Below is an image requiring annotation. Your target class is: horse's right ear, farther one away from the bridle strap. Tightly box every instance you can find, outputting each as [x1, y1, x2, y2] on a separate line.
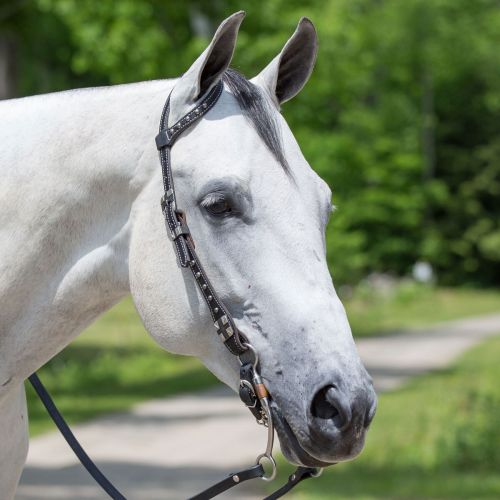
[252, 17, 318, 108]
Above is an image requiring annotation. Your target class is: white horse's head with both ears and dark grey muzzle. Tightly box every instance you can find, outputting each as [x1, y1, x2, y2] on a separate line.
[129, 13, 376, 466]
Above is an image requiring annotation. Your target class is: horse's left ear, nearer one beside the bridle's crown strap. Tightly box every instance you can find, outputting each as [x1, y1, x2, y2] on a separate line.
[168, 10, 245, 125]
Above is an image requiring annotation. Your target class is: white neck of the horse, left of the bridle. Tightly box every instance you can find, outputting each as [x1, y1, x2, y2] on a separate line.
[0, 81, 172, 383]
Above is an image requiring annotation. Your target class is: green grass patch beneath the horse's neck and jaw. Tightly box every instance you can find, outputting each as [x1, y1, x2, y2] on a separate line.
[26, 298, 218, 436]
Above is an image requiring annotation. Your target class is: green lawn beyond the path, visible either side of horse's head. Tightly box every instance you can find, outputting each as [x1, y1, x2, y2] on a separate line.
[27, 286, 500, 435]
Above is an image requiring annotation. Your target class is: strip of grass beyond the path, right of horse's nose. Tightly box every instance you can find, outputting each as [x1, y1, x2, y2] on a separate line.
[342, 283, 500, 337]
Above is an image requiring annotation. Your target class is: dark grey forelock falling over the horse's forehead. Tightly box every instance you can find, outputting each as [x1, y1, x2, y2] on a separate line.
[222, 69, 290, 174]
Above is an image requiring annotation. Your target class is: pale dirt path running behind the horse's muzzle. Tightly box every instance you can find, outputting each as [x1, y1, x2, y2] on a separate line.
[16, 314, 500, 500]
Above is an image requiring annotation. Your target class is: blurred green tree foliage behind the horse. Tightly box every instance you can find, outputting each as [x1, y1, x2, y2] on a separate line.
[0, 0, 500, 285]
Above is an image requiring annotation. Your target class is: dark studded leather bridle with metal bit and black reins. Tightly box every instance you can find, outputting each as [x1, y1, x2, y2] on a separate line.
[29, 81, 321, 500]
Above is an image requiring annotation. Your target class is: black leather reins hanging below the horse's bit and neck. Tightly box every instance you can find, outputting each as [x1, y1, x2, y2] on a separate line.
[28, 373, 317, 500]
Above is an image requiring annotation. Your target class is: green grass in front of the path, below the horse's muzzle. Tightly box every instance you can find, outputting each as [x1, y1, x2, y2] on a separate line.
[270, 337, 500, 500]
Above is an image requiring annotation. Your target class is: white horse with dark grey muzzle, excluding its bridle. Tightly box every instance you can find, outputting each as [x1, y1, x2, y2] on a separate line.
[0, 12, 376, 499]
